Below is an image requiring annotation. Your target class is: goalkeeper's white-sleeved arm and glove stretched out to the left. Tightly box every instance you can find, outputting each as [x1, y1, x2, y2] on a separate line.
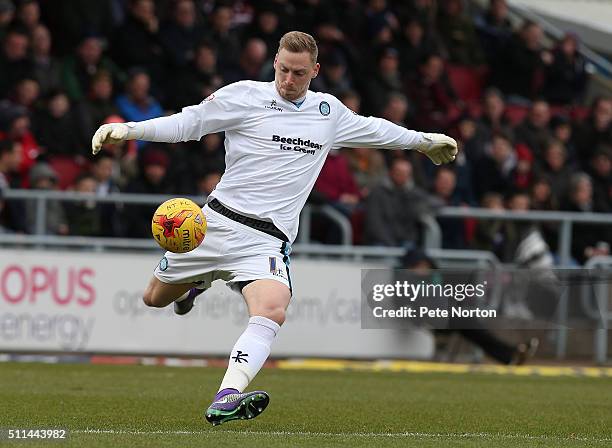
[91, 82, 250, 154]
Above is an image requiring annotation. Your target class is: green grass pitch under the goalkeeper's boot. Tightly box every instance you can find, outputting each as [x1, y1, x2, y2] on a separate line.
[0, 363, 612, 448]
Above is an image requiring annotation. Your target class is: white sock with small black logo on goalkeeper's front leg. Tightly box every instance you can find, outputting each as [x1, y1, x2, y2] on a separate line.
[219, 316, 280, 392]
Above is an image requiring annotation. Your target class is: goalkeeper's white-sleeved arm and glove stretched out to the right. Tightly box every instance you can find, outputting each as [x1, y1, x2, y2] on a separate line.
[334, 101, 457, 165]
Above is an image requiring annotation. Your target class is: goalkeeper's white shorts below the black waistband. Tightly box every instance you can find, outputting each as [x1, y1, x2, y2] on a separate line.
[155, 205, 291, 290]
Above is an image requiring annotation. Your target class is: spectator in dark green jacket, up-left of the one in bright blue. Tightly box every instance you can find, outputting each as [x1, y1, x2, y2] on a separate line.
[62, 36, 123, 101]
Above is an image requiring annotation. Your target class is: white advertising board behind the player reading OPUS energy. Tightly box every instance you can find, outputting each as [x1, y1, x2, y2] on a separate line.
[0, 249, 433, 358]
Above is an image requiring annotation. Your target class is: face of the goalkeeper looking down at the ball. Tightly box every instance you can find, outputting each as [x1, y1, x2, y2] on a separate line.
[274, 48, 319, 101]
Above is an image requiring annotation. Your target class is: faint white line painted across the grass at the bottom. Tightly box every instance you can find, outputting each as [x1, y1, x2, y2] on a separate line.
[70, 428, 612, 442]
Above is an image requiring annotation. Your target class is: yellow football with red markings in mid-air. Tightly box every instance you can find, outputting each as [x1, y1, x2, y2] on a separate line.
[151, 198, 206, 254]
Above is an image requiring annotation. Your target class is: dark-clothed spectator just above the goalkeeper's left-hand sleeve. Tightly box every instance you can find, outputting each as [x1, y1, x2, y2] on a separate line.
[168, 42, 225, 111]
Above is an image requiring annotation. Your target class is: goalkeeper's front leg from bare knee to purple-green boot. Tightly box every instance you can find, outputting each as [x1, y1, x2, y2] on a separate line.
[206, 279, 291, 425]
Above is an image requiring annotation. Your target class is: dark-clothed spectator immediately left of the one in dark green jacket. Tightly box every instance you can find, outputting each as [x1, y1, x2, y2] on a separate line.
[32, 25, 62, 96]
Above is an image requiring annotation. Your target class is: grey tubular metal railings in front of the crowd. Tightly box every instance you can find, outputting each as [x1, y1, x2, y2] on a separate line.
[0, 190, 612, 361]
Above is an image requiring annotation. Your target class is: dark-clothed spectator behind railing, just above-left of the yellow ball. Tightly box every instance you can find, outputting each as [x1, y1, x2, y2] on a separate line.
[125, 147, 174, 238]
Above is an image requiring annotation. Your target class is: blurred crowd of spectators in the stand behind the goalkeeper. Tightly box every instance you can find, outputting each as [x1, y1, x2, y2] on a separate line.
[0, 0, 612, 263]
